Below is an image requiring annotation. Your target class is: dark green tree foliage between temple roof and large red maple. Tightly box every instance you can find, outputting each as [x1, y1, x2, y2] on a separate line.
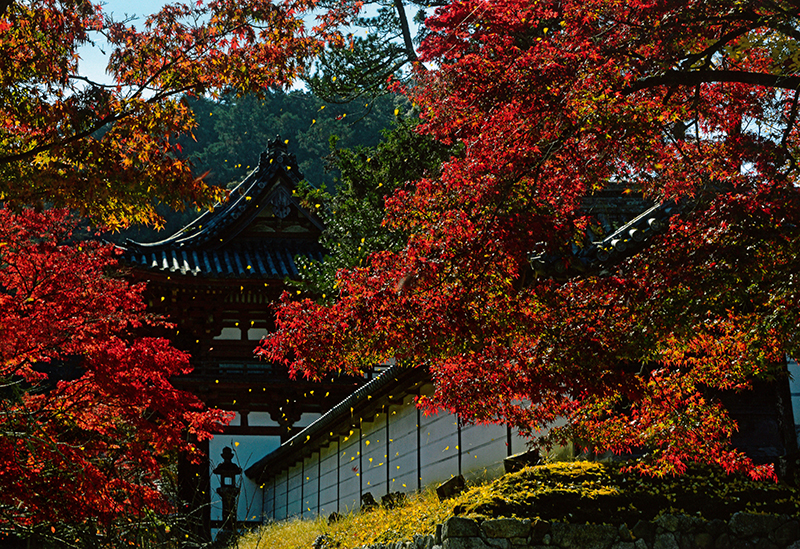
[297, 117, 457, 298]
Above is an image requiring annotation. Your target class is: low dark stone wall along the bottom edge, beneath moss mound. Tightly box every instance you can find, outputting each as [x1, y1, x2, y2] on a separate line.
[354, 513, 800, 549]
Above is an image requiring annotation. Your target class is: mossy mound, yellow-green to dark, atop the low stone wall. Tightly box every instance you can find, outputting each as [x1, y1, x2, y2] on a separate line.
[454, 462, 800, 524]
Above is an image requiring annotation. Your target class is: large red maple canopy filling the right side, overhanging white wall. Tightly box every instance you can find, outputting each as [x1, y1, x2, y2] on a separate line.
[259, 0, 800, 477]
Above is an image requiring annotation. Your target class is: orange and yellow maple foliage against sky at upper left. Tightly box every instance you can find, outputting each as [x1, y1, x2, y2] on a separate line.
[0, 0, 348, 228]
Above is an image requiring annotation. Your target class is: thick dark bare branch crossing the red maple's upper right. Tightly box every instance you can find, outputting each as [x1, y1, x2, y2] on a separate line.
[622, 70, 800, 95]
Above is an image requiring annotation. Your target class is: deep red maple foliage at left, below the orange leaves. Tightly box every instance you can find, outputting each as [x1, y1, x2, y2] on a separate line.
[0, 208, 229, 532]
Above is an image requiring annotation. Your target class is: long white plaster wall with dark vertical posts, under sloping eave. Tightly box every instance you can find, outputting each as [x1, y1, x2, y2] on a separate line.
[264, 397, 548, 520]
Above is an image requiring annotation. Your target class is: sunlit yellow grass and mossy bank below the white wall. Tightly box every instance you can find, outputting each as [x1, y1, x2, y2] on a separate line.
[228, 461, 800, 549]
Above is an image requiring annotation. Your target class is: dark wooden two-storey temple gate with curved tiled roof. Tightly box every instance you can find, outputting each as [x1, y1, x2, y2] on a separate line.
[120, 139, 365, 532]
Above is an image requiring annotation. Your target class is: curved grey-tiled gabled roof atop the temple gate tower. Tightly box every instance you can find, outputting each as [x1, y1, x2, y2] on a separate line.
[120, 138, 323, 280]
